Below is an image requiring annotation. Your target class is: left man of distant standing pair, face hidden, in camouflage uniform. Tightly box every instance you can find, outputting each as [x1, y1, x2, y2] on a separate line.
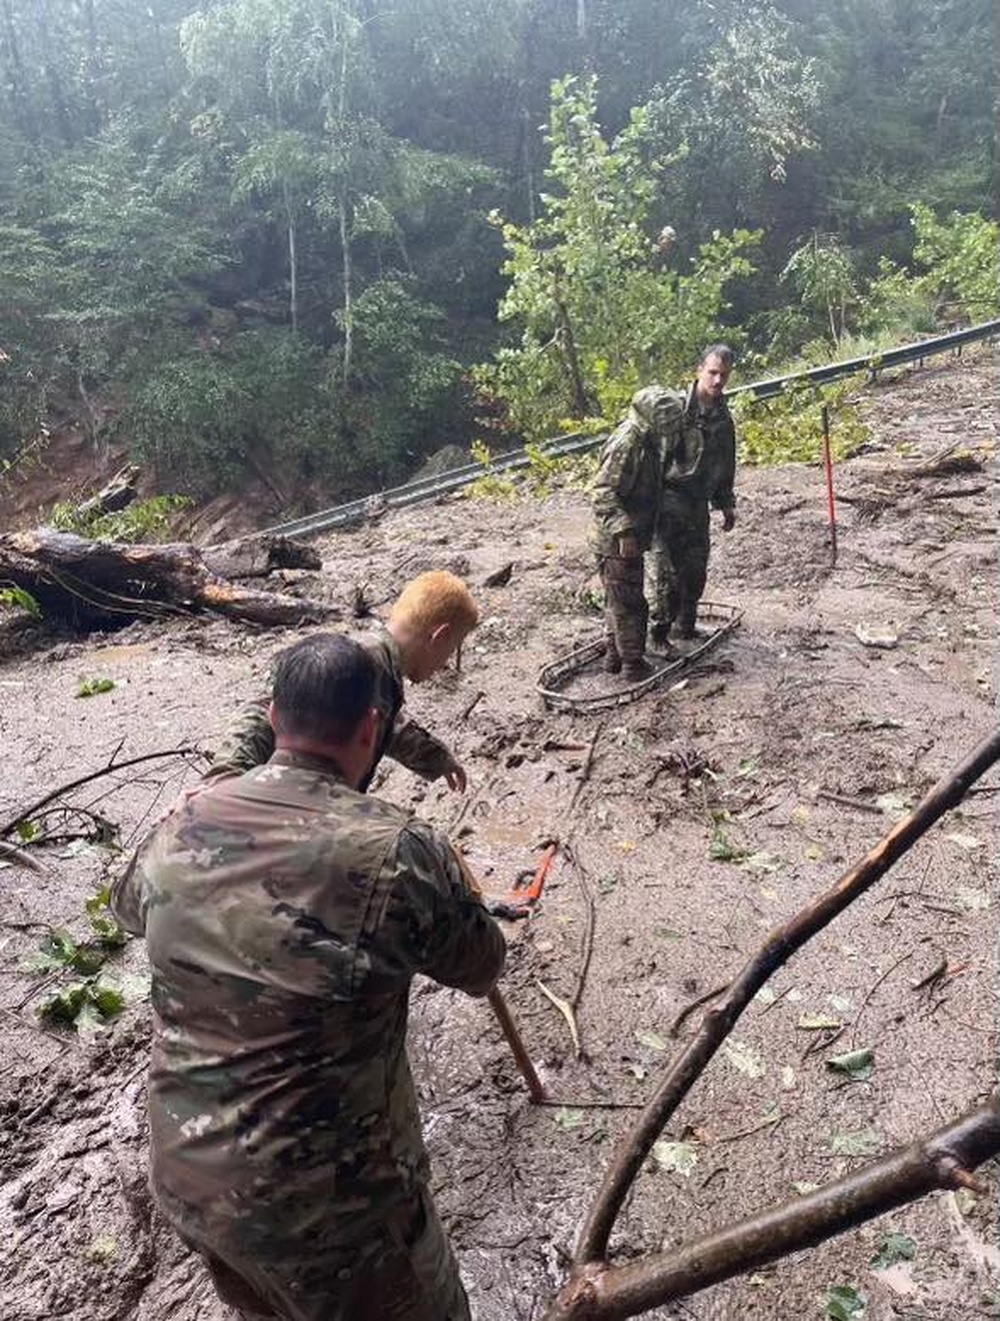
[593, 386, 680, 680]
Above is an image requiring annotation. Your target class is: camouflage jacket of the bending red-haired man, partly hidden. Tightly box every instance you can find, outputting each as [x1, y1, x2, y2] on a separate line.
[205, 629, 454, 791]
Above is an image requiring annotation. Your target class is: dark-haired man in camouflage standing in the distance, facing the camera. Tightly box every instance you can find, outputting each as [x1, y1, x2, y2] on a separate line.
[646, 343, 736, 646]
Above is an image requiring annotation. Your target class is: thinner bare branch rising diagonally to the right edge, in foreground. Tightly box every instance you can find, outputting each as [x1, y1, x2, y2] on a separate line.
[575, 729, 1000, 1262]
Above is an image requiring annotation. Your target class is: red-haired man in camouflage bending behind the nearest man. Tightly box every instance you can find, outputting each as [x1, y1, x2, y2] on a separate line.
[205, 569, 480, 791]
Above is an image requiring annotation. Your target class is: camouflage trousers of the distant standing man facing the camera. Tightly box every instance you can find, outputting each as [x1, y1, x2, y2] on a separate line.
[646, 490, 709, 635]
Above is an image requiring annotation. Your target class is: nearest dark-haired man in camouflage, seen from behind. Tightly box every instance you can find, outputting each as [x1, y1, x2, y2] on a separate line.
[111, 634, 505, 1321]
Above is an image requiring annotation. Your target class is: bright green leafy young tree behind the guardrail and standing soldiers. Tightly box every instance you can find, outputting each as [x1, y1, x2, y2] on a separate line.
[474, 78, 757, 439]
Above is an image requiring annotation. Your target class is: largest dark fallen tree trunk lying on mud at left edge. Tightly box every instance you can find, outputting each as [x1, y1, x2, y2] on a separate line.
[0, 527, 341, 627]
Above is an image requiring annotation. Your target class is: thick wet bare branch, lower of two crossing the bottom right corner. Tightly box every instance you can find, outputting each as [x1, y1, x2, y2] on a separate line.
[544, 1094, 1000, 1321]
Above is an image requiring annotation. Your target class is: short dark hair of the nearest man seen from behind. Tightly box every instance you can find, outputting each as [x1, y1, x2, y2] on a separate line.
[271, 633, 376, 744]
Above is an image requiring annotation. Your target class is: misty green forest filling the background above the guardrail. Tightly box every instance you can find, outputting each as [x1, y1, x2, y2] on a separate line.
[0, 0, 997, 503]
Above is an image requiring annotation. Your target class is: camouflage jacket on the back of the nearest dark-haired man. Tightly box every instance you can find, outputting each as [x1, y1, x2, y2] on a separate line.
[111, 750, 505, 1248]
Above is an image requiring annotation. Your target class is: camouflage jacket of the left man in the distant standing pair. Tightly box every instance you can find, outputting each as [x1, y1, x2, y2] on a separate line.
[593, 386, 683, 556]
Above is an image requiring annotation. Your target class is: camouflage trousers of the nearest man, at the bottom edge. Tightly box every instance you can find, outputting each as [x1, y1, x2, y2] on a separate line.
[169, 1190, 472, 1321]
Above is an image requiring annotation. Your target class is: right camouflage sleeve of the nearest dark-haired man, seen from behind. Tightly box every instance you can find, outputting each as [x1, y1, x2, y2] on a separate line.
[382, 820, 506, 996]
